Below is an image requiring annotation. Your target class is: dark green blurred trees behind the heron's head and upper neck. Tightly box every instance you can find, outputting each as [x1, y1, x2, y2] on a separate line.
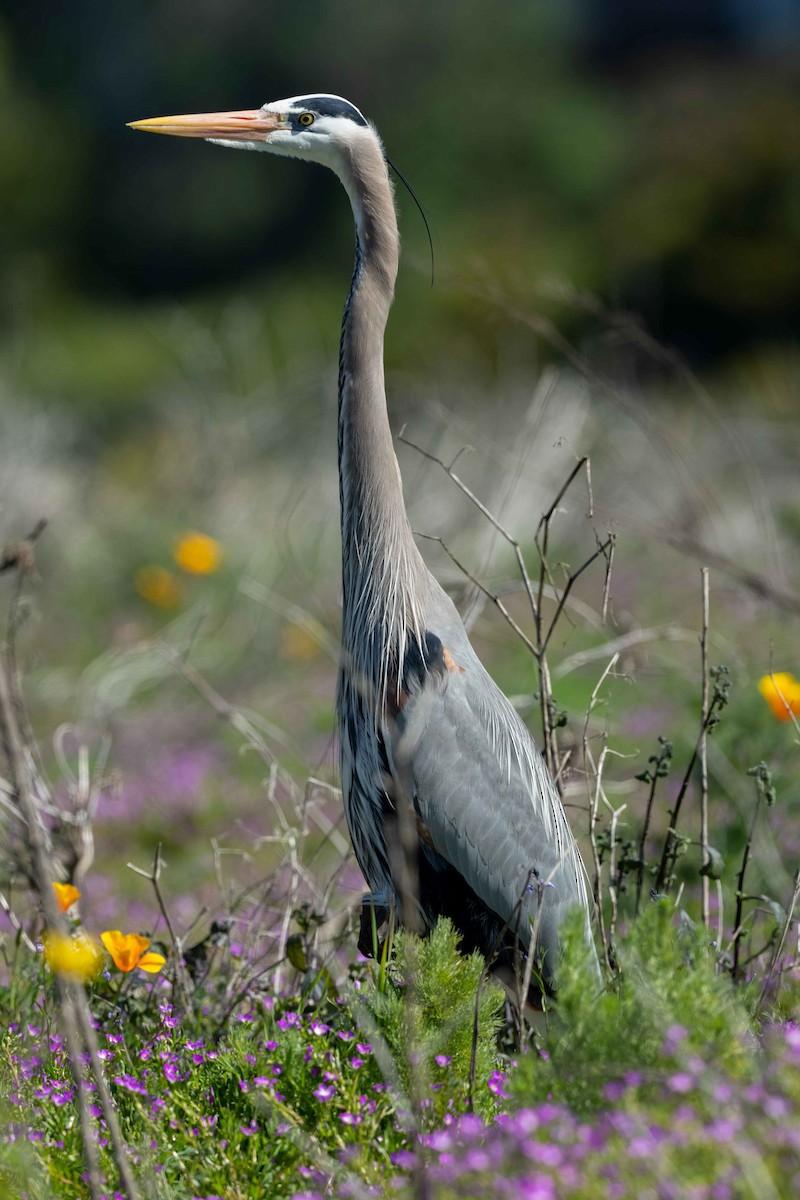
[0, 0, 800, 412]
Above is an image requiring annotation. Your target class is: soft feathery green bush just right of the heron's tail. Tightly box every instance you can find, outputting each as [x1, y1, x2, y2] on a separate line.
[513, 901, 753, 1111]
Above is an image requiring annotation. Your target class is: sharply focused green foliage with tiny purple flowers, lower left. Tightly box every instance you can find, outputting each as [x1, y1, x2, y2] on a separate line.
[0, 923, 499, 1200]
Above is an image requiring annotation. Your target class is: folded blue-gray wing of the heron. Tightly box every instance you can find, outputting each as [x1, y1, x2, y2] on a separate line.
[392, 580, 589, 962]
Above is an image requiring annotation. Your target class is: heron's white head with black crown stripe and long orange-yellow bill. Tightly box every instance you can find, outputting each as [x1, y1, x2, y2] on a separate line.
[131, 95, 372, 169]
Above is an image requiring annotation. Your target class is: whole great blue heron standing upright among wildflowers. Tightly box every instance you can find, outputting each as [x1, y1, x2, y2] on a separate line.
[133, 95, 596, 986]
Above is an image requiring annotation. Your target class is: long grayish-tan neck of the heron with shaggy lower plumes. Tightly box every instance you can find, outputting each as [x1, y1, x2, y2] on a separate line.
[338, 130, 427, 701]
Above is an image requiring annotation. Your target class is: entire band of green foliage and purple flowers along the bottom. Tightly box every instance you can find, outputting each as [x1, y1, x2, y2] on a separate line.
[0, 901, 800, 1200]
